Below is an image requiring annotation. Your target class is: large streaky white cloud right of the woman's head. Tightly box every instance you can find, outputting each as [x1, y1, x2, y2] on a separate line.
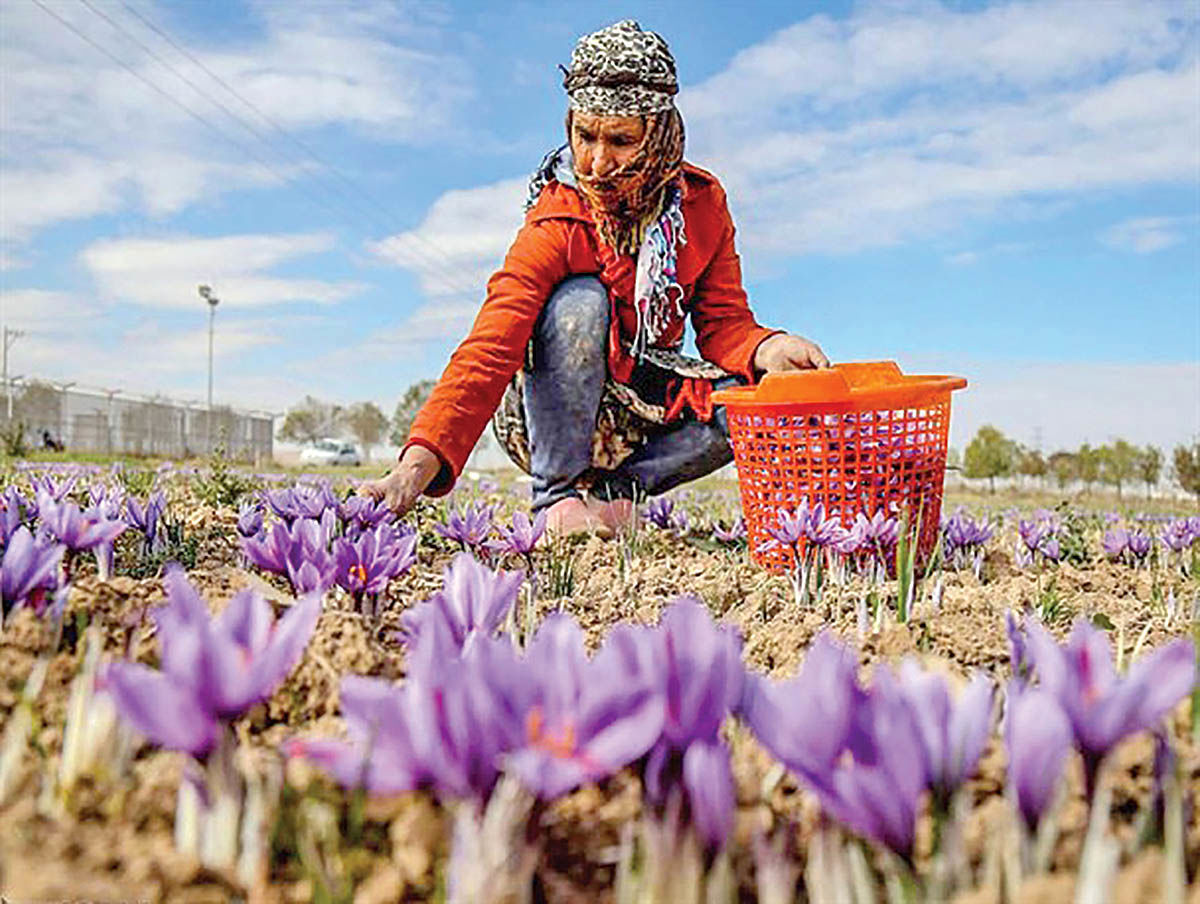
[679, 2, 1200, 255]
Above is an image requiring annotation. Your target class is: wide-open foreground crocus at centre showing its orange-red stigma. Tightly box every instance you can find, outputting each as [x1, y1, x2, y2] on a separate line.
[496, 615, 665, 801]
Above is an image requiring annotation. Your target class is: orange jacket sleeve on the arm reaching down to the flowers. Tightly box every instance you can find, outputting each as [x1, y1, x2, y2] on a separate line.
[401, 220, 568, 496]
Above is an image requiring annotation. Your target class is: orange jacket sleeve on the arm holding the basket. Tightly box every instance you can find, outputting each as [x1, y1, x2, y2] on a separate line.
[691, 186, 782, 383]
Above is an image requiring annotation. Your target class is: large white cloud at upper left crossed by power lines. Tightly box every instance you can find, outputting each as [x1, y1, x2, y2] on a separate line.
[0, 2, 472, 240]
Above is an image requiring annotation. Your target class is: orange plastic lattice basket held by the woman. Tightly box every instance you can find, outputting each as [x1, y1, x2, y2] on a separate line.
[713, 361, 967, 571]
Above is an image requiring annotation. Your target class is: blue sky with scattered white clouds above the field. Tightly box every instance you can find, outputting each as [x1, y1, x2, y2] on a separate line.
[0, 0, 1200, 448]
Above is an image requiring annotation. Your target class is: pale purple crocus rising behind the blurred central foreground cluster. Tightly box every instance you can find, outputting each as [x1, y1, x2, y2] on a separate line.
[401, 552, 524, 651]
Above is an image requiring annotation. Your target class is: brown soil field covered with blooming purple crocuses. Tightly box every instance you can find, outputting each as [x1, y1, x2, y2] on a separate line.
[0, 462, 1200, 904]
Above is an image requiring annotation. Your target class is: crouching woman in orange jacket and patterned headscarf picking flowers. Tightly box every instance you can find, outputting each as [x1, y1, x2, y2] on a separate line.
[364, 20, 828, 535]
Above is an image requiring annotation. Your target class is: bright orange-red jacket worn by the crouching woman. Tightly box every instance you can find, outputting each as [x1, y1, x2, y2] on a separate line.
[406, 163, 778, 496]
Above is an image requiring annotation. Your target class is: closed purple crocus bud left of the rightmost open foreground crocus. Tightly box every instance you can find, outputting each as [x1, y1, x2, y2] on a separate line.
[1004, 681, 1072, 832]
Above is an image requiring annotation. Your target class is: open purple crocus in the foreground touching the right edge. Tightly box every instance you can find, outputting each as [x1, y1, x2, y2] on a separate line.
[1025, 618, 1196, 797]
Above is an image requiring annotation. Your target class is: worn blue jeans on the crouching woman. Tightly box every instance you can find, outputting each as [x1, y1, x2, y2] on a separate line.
[523, 276, 742, 510]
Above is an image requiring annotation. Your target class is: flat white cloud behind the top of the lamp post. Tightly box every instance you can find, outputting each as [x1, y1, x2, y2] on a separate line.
[80, 234, 362, 309]
